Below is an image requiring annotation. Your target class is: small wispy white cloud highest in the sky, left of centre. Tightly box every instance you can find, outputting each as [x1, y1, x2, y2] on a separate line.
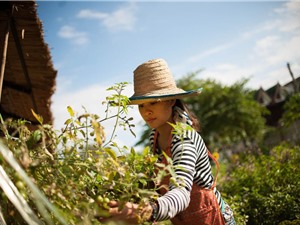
[77, 3, 137, 31]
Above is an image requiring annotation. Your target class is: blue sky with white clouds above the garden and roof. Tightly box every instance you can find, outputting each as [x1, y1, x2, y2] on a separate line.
[37, 1, 300, 149]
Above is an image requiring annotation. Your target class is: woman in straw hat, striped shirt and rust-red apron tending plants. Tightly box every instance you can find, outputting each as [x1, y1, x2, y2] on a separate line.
[99, 59, 235, 225]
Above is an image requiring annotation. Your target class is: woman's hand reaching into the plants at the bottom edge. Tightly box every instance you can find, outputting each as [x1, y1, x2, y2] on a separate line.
[99, 201, 152, 225]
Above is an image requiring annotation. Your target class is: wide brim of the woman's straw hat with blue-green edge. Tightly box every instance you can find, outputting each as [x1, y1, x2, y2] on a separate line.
[128, 88, 202, 105]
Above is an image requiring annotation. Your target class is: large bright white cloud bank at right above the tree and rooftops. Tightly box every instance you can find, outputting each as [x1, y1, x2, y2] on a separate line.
[178, 1, 300, 88]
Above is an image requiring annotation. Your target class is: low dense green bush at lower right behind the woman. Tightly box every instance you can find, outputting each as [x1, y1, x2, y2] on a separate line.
[222, 145, 300, 225]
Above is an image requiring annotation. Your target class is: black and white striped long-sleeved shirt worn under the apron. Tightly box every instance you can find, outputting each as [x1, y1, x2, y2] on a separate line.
[150, 129, 221, 221]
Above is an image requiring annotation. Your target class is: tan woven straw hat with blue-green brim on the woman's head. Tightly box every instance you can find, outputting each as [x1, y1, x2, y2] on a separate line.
[129, 59, 202, 105]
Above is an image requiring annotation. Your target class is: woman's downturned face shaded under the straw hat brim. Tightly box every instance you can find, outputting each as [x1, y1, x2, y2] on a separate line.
[138, 100, 175, 129]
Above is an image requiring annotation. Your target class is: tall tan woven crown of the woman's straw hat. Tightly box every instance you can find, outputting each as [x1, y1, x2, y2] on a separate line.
[133, 59, 183, 96]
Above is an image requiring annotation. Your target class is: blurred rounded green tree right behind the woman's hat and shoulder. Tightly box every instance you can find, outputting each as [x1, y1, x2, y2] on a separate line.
[178, 72, 267, 150]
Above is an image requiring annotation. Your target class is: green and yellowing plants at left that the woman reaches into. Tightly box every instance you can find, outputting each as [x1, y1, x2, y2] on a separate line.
[0, 83, 172, 225]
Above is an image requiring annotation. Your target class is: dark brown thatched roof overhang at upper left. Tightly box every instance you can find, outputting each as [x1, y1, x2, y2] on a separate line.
[0, 1, 57, 124]
